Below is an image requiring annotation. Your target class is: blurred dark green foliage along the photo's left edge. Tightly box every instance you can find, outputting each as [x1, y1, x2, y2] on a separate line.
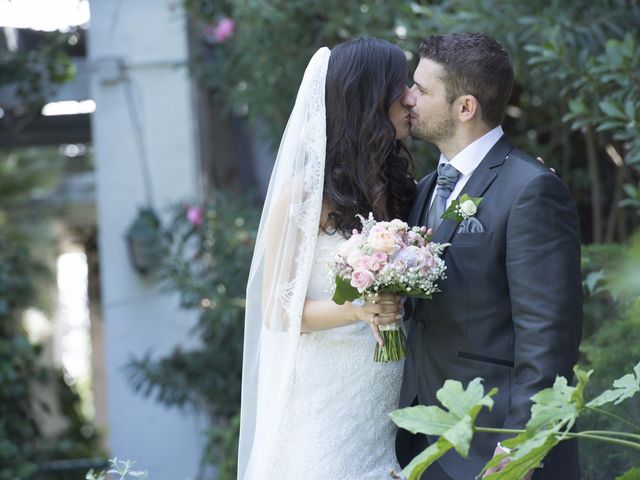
[0, 149, 98, 480]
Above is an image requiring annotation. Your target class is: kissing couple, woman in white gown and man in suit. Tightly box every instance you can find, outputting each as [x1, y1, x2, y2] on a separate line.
[238, 33, 582, 480]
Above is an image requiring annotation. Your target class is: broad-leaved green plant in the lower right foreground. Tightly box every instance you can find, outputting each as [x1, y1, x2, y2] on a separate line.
[390, 363, 640, 480]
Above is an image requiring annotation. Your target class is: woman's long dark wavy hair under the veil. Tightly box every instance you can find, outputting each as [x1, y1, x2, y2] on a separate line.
[323, 38, 416, 237]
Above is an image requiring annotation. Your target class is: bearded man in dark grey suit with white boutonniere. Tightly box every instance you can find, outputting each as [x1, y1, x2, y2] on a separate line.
[396, 33, 582, 480]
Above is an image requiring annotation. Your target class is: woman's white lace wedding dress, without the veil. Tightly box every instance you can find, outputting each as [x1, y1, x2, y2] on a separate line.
[269, 233, 403, 480]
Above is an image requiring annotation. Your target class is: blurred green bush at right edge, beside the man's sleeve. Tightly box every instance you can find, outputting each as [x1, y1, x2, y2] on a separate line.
[579, 240, 640, 480]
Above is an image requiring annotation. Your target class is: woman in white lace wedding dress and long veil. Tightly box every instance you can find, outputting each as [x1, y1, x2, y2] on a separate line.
[238, 39, 416, 480]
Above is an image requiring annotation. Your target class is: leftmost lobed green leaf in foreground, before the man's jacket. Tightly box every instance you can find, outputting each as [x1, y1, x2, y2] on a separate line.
[389, 378, 498, 479]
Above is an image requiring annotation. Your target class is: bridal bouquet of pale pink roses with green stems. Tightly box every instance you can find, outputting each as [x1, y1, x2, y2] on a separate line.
[331, 214, 448, 362]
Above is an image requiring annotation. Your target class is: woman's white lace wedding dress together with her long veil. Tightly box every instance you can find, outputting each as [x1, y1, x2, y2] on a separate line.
[238, 47, 403, 480]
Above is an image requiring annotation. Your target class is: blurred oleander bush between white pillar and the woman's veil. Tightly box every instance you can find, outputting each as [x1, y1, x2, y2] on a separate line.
[128, 194, 259, 479]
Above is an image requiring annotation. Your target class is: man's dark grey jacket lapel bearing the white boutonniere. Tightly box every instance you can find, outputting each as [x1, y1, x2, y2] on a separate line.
[432, 135, 513, 243]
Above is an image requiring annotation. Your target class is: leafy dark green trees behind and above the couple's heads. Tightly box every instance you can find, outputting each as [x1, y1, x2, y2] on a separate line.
[186, 0, 640, 242]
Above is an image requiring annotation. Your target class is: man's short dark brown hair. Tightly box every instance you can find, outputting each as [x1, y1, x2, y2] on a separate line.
[420, 33, 513, 127]
